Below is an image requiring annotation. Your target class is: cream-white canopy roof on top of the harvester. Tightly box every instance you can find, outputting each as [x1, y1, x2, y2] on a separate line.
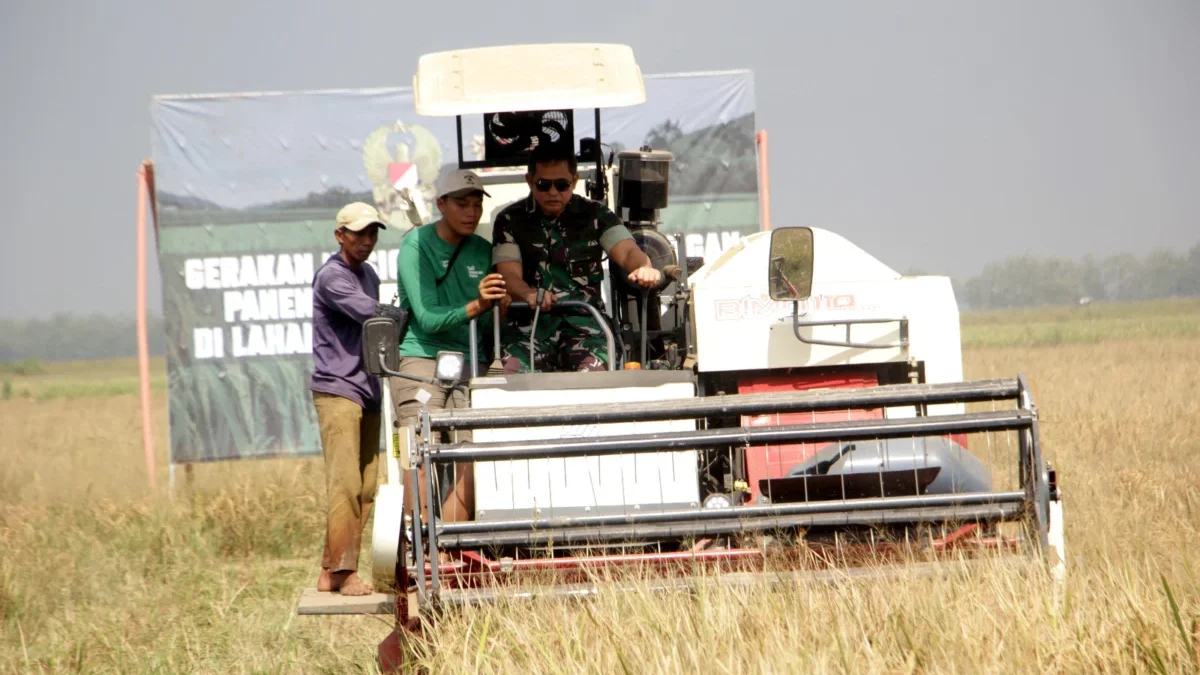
[413, 43, 646, 117]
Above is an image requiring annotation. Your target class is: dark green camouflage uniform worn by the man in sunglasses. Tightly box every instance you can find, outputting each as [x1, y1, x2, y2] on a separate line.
[492, 195, 632, 372]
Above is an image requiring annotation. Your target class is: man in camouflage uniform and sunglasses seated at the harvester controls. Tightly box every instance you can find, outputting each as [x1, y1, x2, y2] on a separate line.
[492, 143, 662, 374]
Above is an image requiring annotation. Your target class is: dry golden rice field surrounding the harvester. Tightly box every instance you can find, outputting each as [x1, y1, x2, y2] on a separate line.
[0, 305, 1200, 673]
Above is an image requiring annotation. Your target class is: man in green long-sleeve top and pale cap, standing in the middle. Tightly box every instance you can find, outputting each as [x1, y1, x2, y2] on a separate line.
[389, 169, 511, 520]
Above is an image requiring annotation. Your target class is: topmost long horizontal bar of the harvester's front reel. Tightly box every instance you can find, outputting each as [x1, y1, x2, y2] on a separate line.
[430, 378, 1020, 430]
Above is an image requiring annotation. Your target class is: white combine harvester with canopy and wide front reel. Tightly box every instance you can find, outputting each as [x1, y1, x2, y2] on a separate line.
[300, 44, 1064, 668]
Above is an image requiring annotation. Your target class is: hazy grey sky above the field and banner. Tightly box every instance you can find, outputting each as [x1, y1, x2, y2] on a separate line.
[0, 0, 1200, 317]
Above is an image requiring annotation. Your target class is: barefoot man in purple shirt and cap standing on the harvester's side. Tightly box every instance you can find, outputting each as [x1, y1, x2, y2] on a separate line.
[308, 202, 384, 596]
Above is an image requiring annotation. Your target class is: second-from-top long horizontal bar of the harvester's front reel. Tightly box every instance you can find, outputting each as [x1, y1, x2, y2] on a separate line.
[428, 410, 1036, 464]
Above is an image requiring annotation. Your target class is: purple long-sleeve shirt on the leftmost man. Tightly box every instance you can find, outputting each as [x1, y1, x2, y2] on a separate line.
[308, 253, 383, 410]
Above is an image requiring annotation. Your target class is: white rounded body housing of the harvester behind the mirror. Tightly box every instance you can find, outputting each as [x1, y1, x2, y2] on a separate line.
[689, 227, 962, 416]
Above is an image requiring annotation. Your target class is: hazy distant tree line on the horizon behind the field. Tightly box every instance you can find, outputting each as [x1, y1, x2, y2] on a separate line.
[0, 243, 1200, 364]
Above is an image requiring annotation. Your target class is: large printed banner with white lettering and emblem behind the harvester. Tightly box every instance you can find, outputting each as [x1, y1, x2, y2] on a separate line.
[151, 71, 758, 464]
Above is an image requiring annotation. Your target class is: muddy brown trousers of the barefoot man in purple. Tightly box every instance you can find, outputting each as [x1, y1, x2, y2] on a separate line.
[312, 392, 380, 572]
